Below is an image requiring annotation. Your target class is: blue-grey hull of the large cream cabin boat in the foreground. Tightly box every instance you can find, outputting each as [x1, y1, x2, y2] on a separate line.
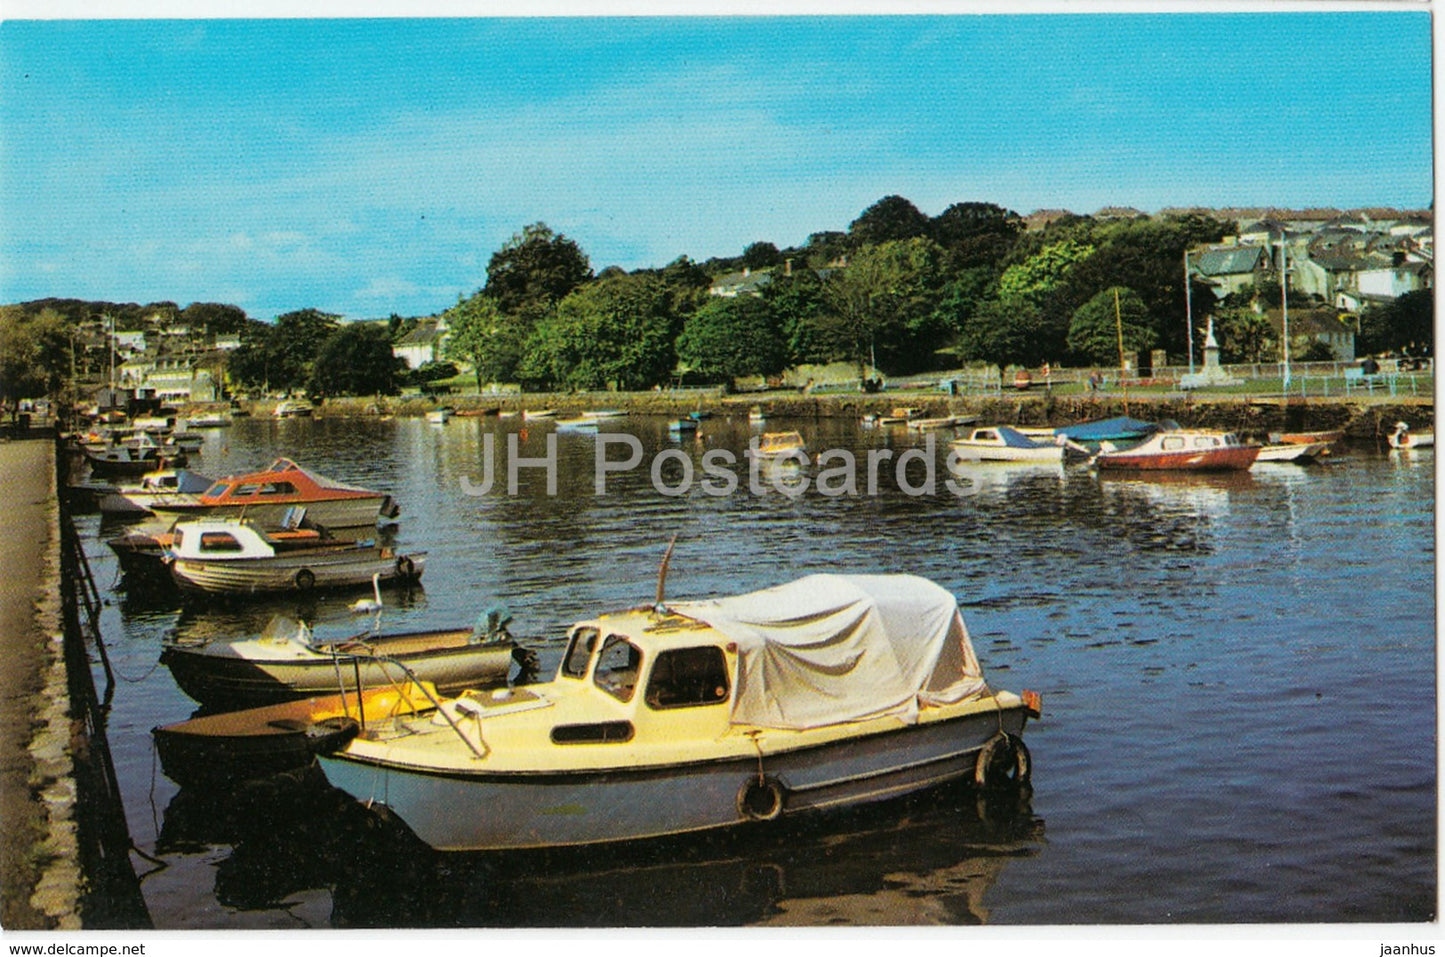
[318, 707, 1027, 850]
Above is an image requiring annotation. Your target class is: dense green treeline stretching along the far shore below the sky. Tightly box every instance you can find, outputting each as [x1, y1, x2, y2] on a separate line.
[0, 195, 1432, 395]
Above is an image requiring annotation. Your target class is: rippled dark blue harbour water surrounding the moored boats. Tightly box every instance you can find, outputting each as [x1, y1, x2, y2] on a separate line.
[79, 416, 1438, 930]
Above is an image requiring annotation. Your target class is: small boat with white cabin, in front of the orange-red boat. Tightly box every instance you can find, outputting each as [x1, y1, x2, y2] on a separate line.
[165, 519, 426, 596]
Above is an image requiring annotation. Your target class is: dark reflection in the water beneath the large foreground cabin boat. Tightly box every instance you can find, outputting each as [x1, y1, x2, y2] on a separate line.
[156, 766, 1043, 928]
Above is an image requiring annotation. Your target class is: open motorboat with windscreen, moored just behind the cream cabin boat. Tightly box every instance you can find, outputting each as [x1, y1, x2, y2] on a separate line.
[160, 617, 517, 705]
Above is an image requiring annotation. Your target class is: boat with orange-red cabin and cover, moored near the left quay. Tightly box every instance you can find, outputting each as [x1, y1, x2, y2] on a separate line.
[152, 458, 402, 528]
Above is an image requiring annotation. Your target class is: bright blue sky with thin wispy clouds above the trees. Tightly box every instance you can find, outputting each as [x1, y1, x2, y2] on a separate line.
[0, 7, 1432, 318]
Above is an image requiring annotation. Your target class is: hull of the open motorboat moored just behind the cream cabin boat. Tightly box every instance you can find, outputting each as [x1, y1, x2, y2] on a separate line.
[160, 629, 516, 705]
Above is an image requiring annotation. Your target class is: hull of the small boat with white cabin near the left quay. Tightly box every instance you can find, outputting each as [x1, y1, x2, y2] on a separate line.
[171, 548, 426, 596]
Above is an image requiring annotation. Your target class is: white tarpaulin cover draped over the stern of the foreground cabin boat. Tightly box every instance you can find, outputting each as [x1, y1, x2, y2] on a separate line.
[669, 575, 984, 729]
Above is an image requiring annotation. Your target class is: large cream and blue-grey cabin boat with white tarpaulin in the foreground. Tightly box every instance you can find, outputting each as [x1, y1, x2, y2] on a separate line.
[318, 575, 1039, 850]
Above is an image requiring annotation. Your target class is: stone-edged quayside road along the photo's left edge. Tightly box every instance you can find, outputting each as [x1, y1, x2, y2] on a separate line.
[0, 438, 78, 930]
